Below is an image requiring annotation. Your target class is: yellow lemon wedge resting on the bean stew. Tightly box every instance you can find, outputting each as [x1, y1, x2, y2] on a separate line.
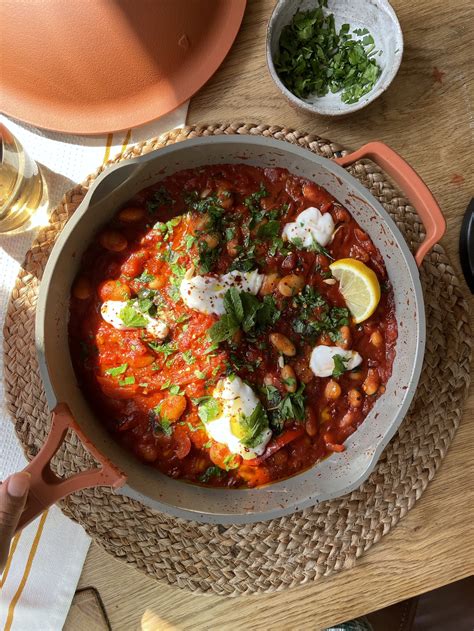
[329, 259, 380, 324]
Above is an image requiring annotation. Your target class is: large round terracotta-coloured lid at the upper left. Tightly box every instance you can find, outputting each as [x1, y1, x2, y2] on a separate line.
[0, 0, 246, 134]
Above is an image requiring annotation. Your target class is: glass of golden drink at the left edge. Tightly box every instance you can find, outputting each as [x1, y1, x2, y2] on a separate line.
[0, 123, 48, 234]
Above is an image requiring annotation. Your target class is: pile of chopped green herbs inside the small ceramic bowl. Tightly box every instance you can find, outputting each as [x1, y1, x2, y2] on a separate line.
[275, 0, 382, 104]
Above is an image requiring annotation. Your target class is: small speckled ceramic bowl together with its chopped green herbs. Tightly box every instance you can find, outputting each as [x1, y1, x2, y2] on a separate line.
[266, 0, 403, 116]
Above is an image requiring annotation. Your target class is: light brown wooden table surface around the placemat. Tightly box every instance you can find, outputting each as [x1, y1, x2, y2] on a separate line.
[65, 0, 474, 631]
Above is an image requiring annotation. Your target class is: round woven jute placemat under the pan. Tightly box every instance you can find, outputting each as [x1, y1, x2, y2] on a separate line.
[4, 123, 472, 595]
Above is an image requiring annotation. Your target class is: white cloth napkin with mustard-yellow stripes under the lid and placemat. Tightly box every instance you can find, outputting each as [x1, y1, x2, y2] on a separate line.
[0, 103, 188, 631]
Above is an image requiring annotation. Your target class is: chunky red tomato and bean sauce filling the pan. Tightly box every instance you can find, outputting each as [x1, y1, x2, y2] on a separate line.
[69, 165, 397, 488]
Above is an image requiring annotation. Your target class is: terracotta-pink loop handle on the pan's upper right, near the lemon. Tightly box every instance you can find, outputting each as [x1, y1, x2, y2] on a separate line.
[335, 142, 446, 267]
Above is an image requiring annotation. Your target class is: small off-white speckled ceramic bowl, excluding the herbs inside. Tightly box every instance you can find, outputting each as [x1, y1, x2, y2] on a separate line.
[267, 0, 403, 116]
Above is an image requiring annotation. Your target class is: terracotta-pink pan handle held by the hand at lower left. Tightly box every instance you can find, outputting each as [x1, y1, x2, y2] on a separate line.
[17, 403, 127, 530]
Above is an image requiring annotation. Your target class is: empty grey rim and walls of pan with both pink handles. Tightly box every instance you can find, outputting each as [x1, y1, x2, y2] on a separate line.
[14, 135, 445, 525]
